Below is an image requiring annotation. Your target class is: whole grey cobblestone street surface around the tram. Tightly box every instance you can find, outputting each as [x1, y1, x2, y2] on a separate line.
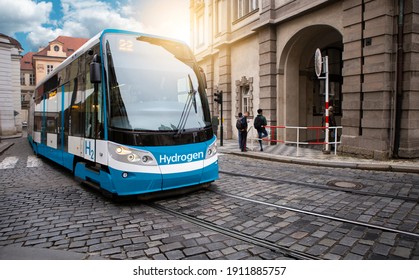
[0, 138, 419, 259]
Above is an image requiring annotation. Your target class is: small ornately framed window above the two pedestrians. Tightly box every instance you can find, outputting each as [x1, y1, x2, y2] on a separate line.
[236, 76, 253, 117]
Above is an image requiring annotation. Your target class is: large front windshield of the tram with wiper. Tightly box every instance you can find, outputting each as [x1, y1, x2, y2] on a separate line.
[104, 34, 211, 132]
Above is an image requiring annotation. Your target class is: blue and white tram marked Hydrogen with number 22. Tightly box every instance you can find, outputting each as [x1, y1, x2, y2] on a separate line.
[28, 29, 218, 196]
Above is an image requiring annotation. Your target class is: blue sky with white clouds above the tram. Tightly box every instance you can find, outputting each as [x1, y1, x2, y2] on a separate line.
[0, 0, 190, 54]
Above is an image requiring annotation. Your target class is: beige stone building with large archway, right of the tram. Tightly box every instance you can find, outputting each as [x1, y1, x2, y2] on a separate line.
[190, 0, 419, 159]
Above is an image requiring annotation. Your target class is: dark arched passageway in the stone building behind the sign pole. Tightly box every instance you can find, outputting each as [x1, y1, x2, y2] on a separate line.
[277, 25, 343, 141]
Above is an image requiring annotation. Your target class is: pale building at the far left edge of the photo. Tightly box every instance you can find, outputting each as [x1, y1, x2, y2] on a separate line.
[0, 34, 23, 137]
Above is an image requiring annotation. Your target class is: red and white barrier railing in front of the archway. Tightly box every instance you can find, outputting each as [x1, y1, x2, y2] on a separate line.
[247, 125, 343, 156]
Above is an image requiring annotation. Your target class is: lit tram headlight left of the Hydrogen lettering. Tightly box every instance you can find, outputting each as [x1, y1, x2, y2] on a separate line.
[108, 142, 157, 165]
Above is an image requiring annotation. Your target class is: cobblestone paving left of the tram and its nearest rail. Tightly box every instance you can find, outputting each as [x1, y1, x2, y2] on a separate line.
[0, 139, 292, 259]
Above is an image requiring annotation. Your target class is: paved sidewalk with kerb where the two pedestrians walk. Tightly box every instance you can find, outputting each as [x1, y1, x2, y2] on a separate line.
[218, 140, 419, 174]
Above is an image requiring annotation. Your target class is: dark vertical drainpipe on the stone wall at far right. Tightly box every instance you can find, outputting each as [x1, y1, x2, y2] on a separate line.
[393, 0, 404, 158]
